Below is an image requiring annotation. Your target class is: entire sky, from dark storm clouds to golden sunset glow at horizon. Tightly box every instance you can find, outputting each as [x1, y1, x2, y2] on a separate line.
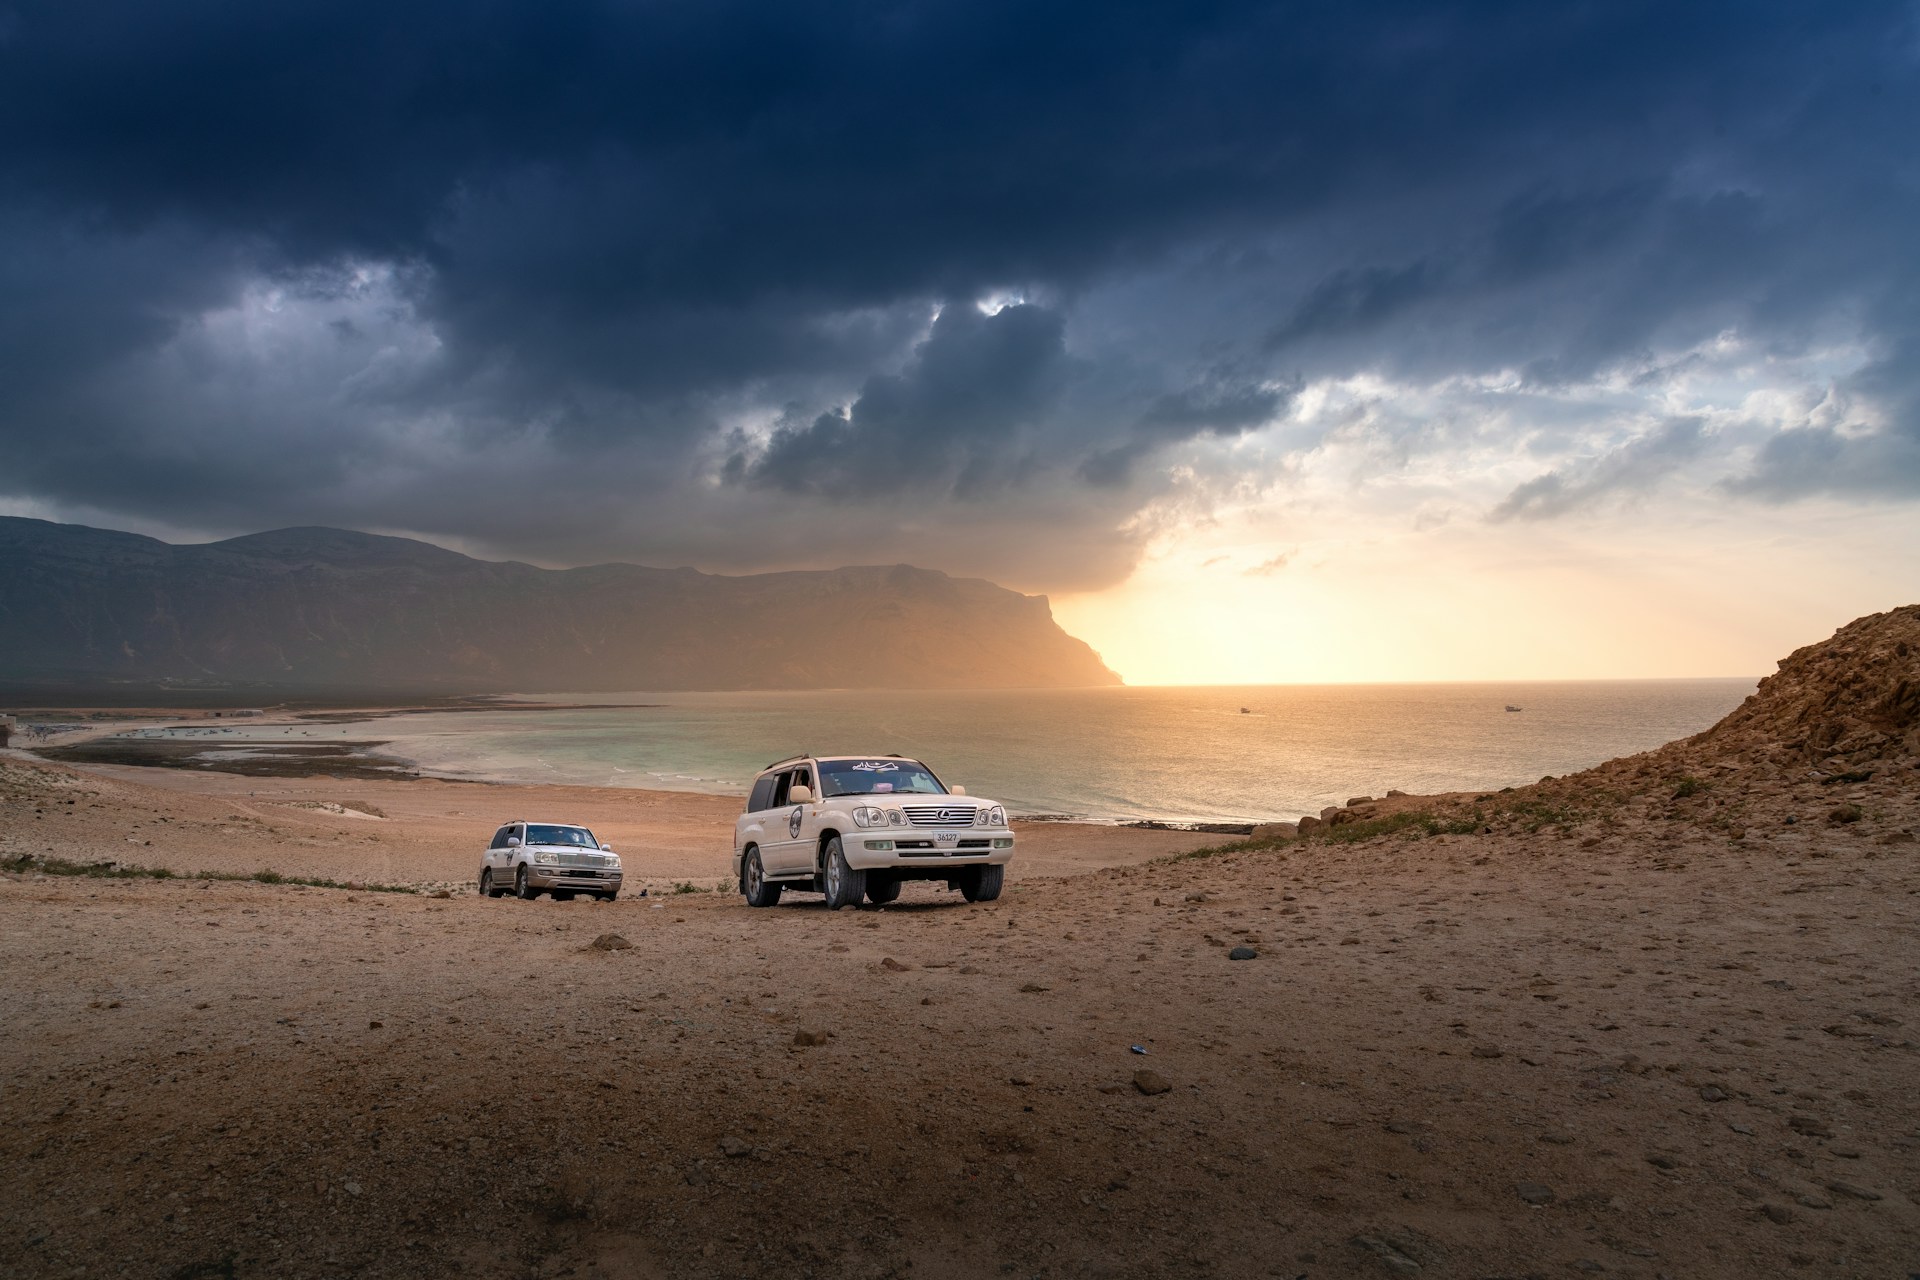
[0, 0, 1920, 683]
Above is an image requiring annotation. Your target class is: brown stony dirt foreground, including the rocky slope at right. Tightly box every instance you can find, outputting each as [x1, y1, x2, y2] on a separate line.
[0, 608, 1920, 1280]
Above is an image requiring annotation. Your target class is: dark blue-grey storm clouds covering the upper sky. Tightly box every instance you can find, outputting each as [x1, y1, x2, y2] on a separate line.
[0, 0, 1920, 585]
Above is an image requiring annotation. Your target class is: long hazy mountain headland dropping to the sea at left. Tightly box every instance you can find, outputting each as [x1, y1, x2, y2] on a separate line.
[0, 518, 1119, 693]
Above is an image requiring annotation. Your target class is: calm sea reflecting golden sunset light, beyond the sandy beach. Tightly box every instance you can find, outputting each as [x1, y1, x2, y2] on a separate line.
[251, 677, 1757, 823]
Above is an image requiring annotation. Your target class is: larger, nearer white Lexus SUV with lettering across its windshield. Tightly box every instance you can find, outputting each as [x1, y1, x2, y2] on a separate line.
[733, 756, 1014, 908]
